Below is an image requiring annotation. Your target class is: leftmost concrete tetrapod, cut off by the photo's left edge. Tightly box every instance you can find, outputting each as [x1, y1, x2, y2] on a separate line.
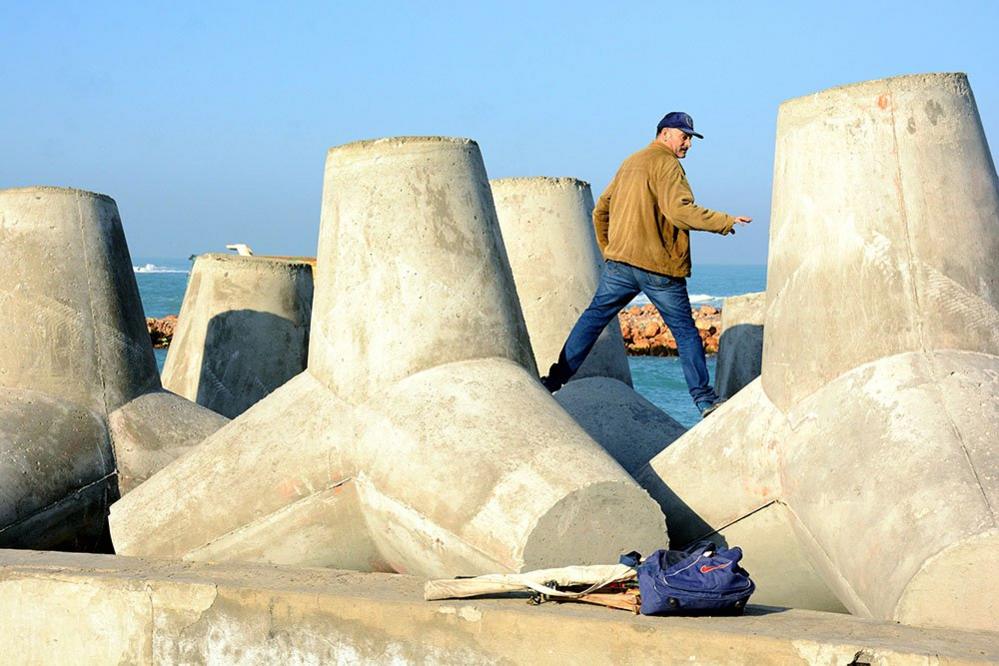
[0, 187, 226, 548]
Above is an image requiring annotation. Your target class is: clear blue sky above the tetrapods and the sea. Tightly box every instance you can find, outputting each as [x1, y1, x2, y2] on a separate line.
[0, 1, 999, 264]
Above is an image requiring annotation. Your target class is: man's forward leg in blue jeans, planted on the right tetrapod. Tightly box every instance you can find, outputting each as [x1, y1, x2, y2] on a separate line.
[636, 269, 718, 404]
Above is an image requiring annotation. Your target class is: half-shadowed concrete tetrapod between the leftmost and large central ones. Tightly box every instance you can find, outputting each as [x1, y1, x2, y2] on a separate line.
[163, 254, 315, 418]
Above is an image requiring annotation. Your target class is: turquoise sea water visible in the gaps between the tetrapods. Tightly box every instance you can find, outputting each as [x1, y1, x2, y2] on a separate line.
[133, 257, 767, 427]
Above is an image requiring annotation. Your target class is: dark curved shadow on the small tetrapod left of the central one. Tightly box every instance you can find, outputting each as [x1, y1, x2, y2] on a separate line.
[197, 310, 309, 418]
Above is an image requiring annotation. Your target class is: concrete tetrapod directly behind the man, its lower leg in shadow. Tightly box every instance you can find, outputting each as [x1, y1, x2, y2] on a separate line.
[490, 177, 686, 474]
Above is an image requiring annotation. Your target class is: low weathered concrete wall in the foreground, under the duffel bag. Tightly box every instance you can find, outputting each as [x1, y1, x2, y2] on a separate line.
[0, 551, 999, 666]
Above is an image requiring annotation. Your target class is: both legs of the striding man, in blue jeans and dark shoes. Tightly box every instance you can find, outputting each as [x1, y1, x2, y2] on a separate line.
[544, 261, 718, 404]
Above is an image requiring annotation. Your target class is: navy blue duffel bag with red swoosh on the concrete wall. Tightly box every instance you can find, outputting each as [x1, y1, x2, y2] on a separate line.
[621, 541, 756, 615]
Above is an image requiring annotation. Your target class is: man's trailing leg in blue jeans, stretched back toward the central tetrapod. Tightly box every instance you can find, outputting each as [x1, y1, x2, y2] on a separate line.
[541, 261, 640, 393]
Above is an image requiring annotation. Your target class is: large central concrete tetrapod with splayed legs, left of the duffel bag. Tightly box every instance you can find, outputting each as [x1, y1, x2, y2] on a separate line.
[111, 137, 665, 576]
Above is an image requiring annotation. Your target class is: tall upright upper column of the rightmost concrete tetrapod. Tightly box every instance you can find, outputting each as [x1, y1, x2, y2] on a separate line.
[763, 74, 999, 410]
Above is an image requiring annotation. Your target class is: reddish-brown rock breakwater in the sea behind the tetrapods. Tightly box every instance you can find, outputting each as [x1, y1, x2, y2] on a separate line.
[146, 304, 722, 356]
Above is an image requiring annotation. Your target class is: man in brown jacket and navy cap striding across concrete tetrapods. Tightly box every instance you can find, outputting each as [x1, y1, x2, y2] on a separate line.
[541, 111, 752, 416]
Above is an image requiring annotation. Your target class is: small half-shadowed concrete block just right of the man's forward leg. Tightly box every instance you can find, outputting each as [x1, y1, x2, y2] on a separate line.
[715, 291, 767, 400]
